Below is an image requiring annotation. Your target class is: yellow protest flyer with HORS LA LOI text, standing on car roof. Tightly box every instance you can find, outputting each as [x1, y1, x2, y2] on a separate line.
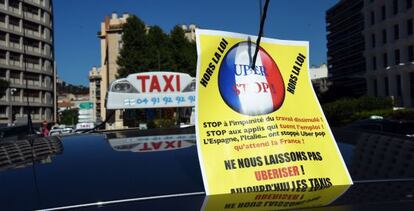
[196, 30, 352, 195]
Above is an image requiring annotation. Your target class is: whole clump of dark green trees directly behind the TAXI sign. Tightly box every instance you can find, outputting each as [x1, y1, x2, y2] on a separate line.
[117, 16, 197, 78]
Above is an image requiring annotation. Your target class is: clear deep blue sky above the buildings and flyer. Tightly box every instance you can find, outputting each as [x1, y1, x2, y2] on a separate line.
[53, 0, 338, 86]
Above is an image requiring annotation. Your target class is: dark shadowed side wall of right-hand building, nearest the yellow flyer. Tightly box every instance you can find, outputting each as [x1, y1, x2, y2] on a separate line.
[326, 0, 366, 97]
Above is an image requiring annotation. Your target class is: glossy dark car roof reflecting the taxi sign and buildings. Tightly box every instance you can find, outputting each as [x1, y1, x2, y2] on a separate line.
[0, 127, 414, 210]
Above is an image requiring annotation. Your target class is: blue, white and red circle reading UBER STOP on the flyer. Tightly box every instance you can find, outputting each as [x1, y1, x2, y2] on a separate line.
[218, 42, 285, 116]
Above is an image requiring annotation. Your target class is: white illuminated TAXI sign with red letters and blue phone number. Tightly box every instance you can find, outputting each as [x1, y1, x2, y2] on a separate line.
[106, 72, 195, 109]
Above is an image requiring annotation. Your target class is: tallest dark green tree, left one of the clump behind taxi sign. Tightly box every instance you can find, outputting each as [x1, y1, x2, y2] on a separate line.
[117, 15, 149, 78]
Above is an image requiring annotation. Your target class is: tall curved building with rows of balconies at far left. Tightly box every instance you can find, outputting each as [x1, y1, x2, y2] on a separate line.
[0, 0, 56, 124]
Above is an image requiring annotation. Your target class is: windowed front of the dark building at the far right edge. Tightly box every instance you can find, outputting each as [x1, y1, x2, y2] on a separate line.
[363, 0, 414, 107]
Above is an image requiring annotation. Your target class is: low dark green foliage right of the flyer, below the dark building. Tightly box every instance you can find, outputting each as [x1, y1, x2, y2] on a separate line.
[322, 97, 392, 126]
